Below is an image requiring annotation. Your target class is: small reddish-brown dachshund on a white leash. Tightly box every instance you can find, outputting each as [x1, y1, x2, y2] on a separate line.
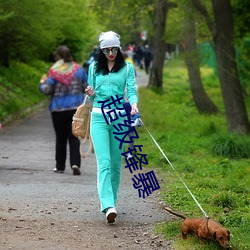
[163, 207, 231, 249]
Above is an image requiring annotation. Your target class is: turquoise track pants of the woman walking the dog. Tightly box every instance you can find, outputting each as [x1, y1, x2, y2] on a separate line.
[90, 112, 125, 212]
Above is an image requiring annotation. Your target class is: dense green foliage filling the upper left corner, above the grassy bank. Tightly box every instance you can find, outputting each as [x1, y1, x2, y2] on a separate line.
[0, 0, 99, 67]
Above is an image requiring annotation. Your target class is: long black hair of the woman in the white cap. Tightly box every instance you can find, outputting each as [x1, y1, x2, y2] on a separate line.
[96, 49, 126, 75]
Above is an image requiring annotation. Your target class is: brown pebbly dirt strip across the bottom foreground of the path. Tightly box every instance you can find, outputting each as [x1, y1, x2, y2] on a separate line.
[0, 214, 173, 250]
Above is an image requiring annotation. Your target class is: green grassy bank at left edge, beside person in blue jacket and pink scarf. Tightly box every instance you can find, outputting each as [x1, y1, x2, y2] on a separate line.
[0, 61, 48, 123]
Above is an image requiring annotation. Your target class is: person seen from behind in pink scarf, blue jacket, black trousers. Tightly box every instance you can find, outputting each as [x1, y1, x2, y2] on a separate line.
[39, 46, 87, 175]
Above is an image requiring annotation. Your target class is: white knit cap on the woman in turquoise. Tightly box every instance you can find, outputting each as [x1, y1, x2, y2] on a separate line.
[99, 31, 121, 49]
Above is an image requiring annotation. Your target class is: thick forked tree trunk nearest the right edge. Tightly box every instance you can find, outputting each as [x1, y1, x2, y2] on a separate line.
[191, 0, 250, 134]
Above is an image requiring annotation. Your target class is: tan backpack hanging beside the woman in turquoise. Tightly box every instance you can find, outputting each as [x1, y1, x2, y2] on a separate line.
[72, 95, 94, 158]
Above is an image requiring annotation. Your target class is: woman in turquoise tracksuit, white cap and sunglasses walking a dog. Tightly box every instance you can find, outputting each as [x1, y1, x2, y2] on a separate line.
[86, 31, 138, 223]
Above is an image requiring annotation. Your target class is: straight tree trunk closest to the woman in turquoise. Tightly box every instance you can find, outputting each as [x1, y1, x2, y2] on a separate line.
[148, 0, 168, 89]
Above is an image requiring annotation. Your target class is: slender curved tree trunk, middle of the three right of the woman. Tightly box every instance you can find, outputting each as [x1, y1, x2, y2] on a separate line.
[185, 3, 218, 114]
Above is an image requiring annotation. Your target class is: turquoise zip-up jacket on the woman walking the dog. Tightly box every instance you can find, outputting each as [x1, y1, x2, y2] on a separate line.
[88, 62, 138, 108]
